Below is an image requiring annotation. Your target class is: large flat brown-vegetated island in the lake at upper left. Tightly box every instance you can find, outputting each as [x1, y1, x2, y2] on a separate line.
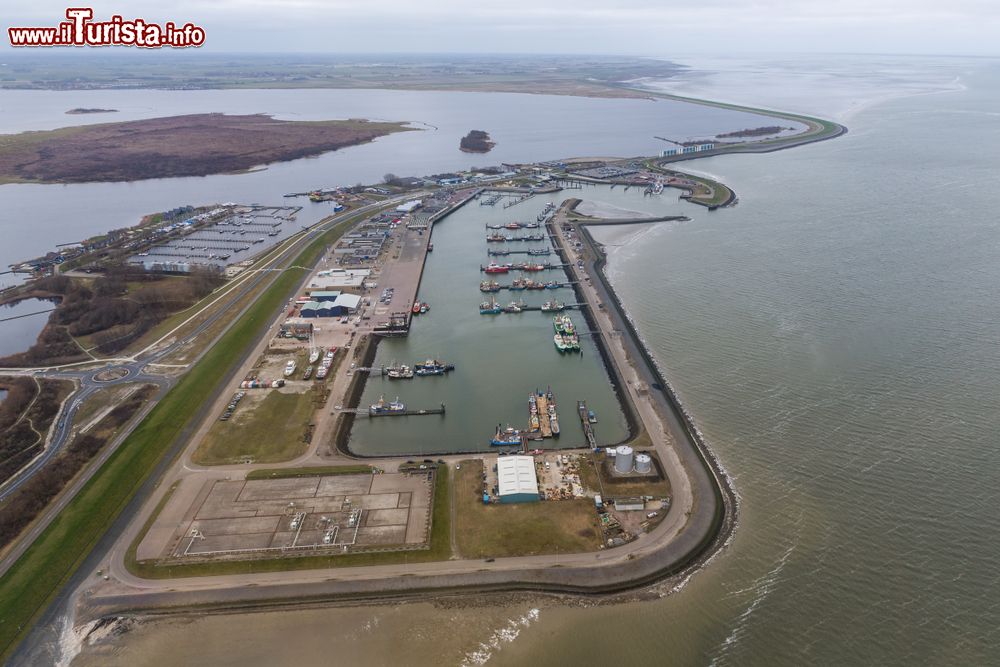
[0, 113, 413, 183]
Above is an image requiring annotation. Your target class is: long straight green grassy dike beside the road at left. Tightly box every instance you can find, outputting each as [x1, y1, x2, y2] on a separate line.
[0, 211, 368, 659]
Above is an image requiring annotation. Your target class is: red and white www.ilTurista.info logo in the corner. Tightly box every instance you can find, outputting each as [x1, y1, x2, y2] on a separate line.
[7, 7, 205, 49]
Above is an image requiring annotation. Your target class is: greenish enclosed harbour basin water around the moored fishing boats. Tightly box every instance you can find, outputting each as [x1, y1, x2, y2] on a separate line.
[348, 188, 640, 456]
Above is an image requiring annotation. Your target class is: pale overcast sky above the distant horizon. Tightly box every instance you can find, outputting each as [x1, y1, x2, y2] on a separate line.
[2, 0, 1000, 57]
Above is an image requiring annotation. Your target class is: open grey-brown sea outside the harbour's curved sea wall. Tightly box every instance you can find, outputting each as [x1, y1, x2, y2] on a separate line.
[68, 59, 1000, 666]
